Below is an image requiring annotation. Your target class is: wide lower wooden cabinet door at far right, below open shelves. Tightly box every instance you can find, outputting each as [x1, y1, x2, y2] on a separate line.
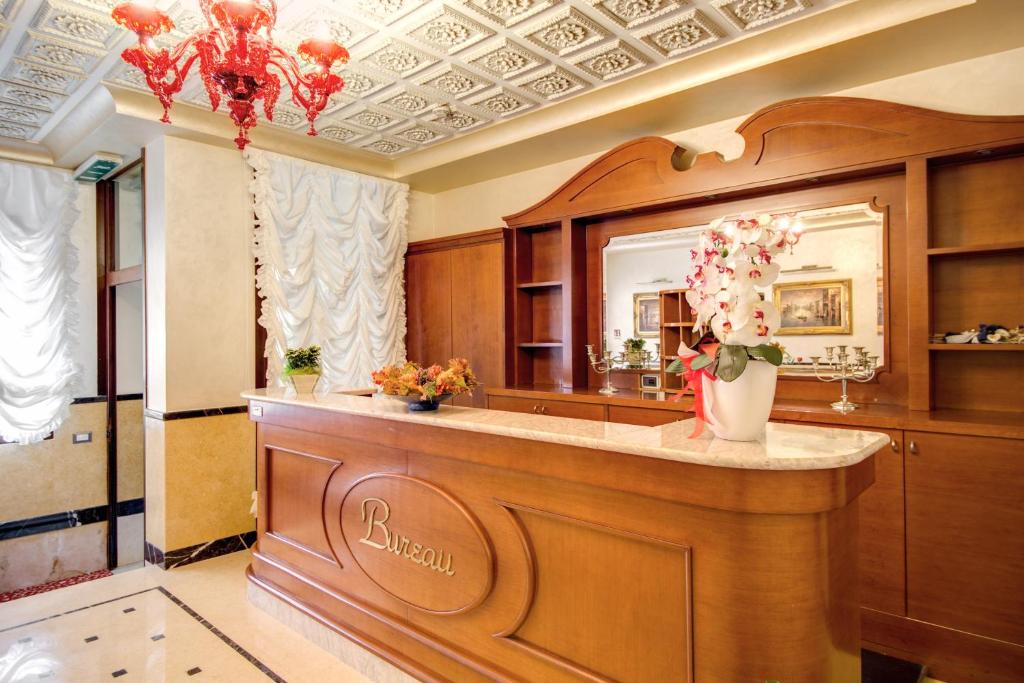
[906, 432, 1024, 644]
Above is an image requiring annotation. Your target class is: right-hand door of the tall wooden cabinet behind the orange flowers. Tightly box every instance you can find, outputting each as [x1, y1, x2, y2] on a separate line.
[454, 242, 505, 408]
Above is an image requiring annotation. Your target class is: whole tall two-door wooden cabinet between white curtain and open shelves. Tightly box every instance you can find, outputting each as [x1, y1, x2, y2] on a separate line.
[406, 229, 508, 408]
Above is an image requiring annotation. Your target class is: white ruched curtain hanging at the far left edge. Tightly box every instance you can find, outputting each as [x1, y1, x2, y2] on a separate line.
[0, 161, 79, 443]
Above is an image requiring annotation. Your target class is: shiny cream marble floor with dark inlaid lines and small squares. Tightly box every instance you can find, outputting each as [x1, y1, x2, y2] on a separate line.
[0, 551, 950, 683]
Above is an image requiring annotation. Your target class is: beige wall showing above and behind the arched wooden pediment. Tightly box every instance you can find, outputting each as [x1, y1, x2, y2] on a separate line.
[409, 48, 1024, 242]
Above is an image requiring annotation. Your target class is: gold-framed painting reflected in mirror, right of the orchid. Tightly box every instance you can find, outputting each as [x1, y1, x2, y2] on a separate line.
[772, 280, 853, 335]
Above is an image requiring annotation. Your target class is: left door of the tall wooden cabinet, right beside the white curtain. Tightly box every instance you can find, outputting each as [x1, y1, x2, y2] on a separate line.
[406, 251, 452, 365]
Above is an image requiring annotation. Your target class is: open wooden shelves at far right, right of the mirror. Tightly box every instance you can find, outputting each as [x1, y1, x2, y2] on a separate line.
[925, 154, 1024, 412]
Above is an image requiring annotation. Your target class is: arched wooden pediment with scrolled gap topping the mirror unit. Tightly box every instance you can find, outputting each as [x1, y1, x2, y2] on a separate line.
[505, 97, 1024, 227]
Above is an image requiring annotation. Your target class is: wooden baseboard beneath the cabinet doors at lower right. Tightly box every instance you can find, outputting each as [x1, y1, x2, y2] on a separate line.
[860, 607, 1024, 683]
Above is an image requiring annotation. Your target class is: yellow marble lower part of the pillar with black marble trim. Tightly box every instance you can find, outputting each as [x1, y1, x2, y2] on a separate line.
[145, 407, 256, 569]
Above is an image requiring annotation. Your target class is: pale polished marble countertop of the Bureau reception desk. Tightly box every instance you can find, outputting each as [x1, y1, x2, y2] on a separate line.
[242, 389, 889, 470]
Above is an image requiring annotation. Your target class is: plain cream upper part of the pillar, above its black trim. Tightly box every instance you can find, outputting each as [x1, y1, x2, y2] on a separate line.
[145, 137, 255, 412]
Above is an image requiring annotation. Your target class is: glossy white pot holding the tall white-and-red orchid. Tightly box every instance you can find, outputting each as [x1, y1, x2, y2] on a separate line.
[703, 360, 778, 441]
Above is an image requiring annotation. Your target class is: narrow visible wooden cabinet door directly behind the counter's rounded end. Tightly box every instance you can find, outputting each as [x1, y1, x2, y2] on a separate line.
[860, 428, 906, 616]
